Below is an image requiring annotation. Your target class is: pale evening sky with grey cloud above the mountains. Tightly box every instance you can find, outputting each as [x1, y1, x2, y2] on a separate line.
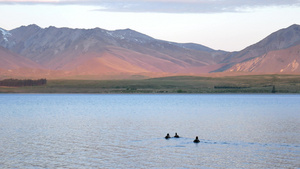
[0, 0, 300, 51]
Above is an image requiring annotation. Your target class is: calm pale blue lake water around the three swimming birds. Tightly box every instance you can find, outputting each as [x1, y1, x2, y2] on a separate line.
[0, 94, 300, 168]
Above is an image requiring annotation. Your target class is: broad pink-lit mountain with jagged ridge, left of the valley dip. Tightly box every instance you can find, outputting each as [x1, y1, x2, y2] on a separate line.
[0, 25, 224, 74]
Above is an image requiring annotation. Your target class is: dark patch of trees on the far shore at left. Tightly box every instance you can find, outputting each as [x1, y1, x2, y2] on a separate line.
[0, 79, 47, 87]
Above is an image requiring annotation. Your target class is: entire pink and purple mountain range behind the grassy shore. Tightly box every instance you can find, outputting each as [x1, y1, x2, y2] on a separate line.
[0, 25, 300, 79]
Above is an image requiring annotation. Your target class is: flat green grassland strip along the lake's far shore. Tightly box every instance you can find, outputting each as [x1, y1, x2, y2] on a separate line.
[0, 75, 300, 93]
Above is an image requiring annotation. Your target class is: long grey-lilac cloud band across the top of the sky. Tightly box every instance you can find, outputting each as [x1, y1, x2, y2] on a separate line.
[0, 0, 300, 13]
